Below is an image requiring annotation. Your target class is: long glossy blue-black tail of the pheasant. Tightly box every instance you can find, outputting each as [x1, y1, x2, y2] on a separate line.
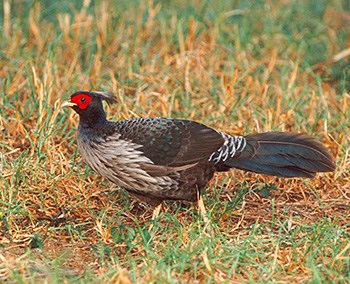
[222, 132, 336, 177]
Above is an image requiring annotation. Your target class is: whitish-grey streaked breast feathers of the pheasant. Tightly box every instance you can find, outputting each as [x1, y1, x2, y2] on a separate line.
[78, 134, 175, 193]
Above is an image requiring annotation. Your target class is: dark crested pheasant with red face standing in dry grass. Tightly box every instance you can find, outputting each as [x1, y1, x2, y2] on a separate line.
[62, 91, 336, 206]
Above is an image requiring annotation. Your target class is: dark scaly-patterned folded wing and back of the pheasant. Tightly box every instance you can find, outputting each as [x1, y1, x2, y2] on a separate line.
[116, 118, 224, 167]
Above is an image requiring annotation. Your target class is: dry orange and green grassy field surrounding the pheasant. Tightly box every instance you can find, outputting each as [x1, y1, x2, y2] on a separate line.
[0, 0, 350, 283]
